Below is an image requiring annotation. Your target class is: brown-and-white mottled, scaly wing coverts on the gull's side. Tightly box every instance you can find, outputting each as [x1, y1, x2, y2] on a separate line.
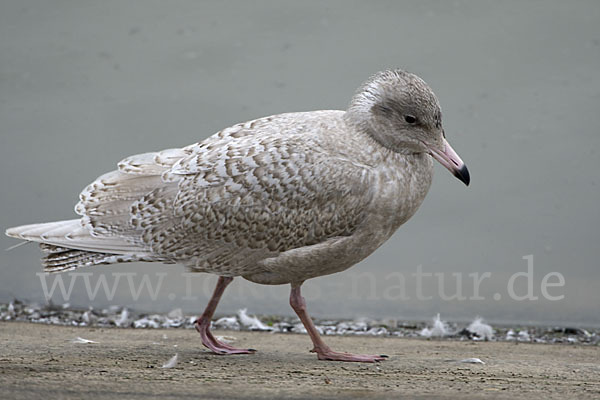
[132, 111, 373, 274]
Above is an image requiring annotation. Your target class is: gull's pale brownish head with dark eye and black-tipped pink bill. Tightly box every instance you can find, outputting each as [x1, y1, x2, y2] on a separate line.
[346, 69, 470, 185]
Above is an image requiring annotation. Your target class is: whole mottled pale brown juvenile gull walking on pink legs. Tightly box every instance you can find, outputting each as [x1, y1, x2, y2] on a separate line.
[6, 70, 469, 362]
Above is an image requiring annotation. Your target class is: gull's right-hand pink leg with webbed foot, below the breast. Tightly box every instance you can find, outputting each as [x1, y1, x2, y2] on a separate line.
[290, 284, 387, 362]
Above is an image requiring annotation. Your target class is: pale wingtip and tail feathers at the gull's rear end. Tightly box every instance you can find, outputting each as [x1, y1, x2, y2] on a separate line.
[6, 146, 192, 272]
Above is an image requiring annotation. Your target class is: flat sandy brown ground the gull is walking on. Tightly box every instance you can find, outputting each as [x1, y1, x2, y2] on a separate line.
[0, 322, 600, 399]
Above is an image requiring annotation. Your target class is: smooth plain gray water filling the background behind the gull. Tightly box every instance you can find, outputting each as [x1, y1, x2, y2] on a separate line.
[0, 0, 600, 326]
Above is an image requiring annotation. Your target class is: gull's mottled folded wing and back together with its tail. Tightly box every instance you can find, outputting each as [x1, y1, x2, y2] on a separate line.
[7, 112, 376, 276]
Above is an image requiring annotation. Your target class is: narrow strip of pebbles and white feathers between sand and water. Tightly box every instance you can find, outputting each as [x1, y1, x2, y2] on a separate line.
[0, 300, 600, 345]
